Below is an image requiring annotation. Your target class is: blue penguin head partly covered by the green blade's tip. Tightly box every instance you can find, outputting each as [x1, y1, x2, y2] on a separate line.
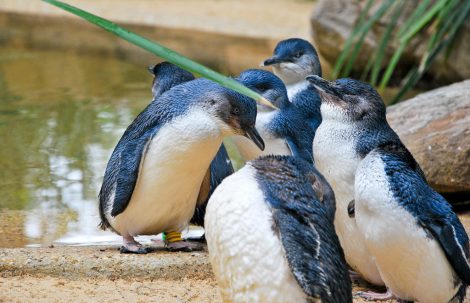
[237, 69, 290, 110]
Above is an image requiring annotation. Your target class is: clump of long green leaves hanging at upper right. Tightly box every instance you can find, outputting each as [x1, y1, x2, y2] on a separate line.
[333, 0, 470, 104]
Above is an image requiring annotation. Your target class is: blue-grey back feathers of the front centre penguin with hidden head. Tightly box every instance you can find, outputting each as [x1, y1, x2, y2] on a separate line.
[251, 156, 352, 302]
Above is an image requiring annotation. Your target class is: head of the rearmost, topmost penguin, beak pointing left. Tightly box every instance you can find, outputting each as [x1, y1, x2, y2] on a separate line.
[262, 38, 321, 84]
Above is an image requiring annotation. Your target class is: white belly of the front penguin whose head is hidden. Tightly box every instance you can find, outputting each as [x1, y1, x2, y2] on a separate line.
[205, 164, 306, 303]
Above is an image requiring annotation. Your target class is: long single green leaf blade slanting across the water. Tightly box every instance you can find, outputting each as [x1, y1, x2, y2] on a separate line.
[43, 0, 277, 109]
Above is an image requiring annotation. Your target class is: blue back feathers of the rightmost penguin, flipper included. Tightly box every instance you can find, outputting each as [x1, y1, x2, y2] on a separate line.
[376, 142, 470, 294]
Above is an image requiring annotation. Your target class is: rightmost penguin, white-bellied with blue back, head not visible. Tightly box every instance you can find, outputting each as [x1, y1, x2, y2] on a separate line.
[354, 143, 470, 302]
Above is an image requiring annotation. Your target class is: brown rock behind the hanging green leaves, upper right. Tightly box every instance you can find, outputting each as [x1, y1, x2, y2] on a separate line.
[310, 0, 470, 83]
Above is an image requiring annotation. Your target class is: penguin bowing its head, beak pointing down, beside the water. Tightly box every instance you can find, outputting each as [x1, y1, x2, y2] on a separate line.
[99, 79, 264, 253]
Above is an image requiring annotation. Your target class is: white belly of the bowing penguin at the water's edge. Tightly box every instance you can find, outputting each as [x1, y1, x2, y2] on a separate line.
[108, 111, 222, 236]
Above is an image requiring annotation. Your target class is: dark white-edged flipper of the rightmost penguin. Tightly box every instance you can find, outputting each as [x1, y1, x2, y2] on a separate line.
[421, 220, 470, 285]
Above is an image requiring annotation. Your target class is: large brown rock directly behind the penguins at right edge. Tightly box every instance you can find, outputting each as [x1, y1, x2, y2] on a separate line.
[387, 80, 470, 200]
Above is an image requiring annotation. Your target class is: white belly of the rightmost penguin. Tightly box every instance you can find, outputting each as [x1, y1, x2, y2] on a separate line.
[355, 154, 460, 303]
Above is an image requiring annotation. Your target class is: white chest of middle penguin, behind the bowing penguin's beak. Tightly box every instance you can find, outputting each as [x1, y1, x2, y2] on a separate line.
[233, 111, 291, 161]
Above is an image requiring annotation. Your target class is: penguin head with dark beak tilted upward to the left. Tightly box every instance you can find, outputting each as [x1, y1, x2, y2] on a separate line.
[307, 75, 386, 124]
